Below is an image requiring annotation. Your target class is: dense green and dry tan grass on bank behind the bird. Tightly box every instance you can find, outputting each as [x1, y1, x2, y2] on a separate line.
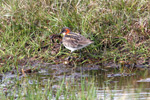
[0, 0, 150, 71]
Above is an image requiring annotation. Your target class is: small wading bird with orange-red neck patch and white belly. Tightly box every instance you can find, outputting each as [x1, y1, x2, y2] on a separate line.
[60, 27, 94, 59]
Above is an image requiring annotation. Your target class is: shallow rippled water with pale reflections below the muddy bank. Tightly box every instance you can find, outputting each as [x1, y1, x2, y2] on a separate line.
[0, 64, 150, 100]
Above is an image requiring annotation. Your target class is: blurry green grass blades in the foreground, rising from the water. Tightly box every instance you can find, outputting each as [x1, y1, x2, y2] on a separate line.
[0, 74, 97, 100]
